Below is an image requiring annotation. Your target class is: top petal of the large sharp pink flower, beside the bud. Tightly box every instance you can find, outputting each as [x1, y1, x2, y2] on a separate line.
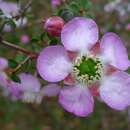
[61, 17, 98, 51]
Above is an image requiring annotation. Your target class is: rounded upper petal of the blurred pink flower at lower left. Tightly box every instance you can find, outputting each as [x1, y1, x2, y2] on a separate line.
[19, 73, 41, 92]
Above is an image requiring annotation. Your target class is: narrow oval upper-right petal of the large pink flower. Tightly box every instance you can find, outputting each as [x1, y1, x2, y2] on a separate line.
[100, 32, 130, 70]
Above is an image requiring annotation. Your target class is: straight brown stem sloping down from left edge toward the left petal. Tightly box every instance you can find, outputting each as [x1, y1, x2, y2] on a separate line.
[1, 40, 37, 58]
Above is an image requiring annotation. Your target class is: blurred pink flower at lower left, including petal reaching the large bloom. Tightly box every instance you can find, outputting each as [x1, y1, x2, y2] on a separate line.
[8, 73, 60, 103]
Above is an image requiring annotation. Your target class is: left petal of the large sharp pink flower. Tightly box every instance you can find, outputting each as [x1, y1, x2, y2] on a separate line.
[37, 45, 72, 82]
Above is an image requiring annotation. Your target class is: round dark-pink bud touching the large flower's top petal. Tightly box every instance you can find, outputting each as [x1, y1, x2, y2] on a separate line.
[44, 16, 64, 37]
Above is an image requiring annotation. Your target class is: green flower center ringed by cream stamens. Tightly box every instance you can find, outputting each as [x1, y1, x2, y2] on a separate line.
[73, 56, 103, 84]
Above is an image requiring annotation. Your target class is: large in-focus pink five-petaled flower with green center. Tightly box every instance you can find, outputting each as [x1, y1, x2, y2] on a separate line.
[37, 17, 130, 117]
